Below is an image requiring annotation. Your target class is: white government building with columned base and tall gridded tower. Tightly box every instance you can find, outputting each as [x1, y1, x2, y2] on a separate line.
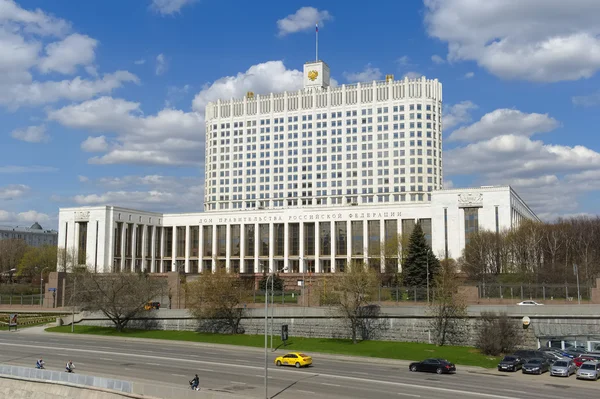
[58, 61, 538, 273]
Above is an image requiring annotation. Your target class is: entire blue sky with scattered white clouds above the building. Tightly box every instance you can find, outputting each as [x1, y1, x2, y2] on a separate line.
[0, 0, 600, 228]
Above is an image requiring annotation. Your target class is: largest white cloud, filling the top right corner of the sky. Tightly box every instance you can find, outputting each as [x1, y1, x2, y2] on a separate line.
[424, 0, 600, 82]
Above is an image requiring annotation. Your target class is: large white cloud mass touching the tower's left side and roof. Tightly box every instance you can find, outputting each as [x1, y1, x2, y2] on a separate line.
[48, 61, 310, 168]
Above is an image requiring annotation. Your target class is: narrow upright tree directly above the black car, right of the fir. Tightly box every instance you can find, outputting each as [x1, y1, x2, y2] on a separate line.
[429, 259, 468, 346]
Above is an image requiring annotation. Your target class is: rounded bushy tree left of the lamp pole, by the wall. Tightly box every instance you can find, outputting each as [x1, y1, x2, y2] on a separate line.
[187, 267, 249, 334]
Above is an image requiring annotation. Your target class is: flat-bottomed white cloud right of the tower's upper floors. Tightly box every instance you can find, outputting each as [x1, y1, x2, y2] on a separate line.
[448, 109, 560, 141]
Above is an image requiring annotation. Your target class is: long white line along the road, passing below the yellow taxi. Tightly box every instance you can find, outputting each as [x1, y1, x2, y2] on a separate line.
[0, 342, 520, 399]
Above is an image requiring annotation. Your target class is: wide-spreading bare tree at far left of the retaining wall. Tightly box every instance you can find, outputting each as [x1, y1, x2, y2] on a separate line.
[72, 270, 166, 331]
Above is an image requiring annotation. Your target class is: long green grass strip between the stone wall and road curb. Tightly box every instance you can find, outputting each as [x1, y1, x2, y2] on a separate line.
[46, 326, 500, 368]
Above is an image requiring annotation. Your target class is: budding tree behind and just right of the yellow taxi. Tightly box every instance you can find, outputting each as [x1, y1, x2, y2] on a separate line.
[335, 264, 379, 343]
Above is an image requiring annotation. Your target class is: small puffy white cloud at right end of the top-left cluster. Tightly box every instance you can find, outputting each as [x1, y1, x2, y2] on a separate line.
[38, 33, 98, 75]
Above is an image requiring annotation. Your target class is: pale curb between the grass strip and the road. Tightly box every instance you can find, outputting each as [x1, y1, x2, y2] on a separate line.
[43, 331, 495, 372]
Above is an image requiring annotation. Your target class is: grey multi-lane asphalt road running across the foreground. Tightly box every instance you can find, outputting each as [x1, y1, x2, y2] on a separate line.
[0, 330, 600, 399]
